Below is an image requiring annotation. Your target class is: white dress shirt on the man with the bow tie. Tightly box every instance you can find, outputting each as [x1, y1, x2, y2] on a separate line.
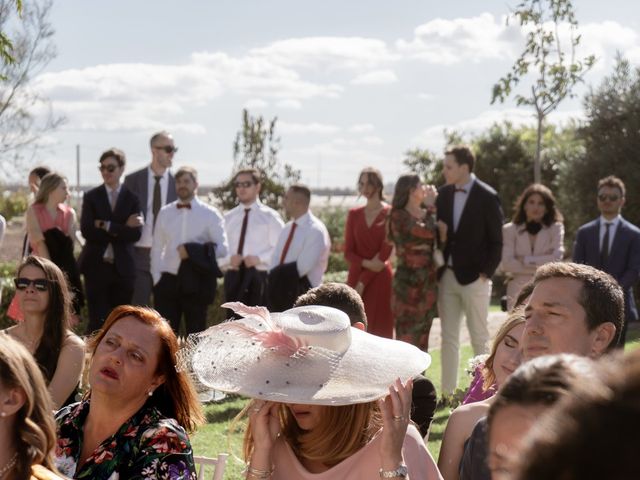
[151, 198, 228, 284]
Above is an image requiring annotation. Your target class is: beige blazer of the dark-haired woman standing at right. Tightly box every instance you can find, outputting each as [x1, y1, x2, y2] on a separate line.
[500, 222, 564, 308]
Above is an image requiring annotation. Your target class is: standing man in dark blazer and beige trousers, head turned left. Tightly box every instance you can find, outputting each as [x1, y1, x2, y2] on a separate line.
[436, 146, 503, 394]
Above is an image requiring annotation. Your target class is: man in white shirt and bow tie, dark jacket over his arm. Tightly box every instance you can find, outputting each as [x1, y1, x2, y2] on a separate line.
[151, 167, 228, 334]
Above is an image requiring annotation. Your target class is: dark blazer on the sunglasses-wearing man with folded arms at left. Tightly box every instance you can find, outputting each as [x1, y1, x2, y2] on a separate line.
[78, 185, 142, 277]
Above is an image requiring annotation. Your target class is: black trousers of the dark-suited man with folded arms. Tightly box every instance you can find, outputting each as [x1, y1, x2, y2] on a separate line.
[84, 262, 135, 335]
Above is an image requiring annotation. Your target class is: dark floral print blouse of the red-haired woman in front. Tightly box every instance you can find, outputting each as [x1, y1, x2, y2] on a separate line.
[56, 400, 196, 480]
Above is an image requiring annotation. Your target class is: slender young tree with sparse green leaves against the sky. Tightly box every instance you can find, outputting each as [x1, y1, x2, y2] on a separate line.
[491, 0, 595, 182]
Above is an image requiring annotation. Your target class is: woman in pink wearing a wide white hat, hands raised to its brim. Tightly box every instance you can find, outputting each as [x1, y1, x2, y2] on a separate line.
[188, 303, 442, 480]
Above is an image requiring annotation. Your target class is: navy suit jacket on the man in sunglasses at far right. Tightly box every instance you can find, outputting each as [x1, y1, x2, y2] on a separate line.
[573, 217, 640, 321]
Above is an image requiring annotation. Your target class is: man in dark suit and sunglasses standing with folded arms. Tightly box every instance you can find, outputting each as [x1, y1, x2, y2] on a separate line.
[78, 148, 143, 333]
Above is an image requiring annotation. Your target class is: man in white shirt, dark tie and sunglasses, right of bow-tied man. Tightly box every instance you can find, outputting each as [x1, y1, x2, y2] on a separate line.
[220, 168, 284, 312]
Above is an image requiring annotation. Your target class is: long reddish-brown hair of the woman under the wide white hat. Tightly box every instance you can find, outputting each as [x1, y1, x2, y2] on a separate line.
[239, 401, 382, 467]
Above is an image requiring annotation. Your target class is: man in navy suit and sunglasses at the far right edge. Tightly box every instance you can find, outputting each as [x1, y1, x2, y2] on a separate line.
[573, 176, 640, 348]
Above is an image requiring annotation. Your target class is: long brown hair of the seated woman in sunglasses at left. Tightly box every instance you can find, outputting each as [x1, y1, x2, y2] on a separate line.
[17, 255, 72, 383]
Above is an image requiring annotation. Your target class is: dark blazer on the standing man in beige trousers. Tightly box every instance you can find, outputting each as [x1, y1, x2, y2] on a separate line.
[436, 178, 503, 285]
